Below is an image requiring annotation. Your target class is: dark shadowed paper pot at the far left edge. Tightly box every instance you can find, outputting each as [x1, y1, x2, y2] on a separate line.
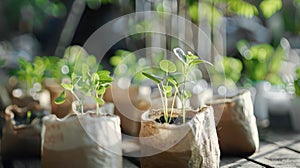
[1, 105, 42, 159]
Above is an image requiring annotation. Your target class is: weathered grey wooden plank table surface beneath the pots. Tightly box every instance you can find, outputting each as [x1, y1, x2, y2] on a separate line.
[0, 129, 300, 168]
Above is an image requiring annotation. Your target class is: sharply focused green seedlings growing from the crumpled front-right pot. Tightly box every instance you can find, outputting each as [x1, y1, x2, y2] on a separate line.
[143, 48, 211, 123]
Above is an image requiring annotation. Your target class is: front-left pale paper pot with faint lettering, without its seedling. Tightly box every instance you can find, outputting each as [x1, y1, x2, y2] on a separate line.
[42, 104, 122, 168]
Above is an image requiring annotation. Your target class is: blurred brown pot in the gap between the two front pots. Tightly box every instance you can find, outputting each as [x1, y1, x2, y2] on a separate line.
[104, 84, 151, 137]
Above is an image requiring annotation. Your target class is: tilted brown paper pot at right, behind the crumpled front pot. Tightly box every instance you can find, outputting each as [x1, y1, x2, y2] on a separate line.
[207, 91, 259, 156]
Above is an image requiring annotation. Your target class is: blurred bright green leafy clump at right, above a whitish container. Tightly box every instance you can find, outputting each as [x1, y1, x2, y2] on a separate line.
[237, 40, 285, 84]
